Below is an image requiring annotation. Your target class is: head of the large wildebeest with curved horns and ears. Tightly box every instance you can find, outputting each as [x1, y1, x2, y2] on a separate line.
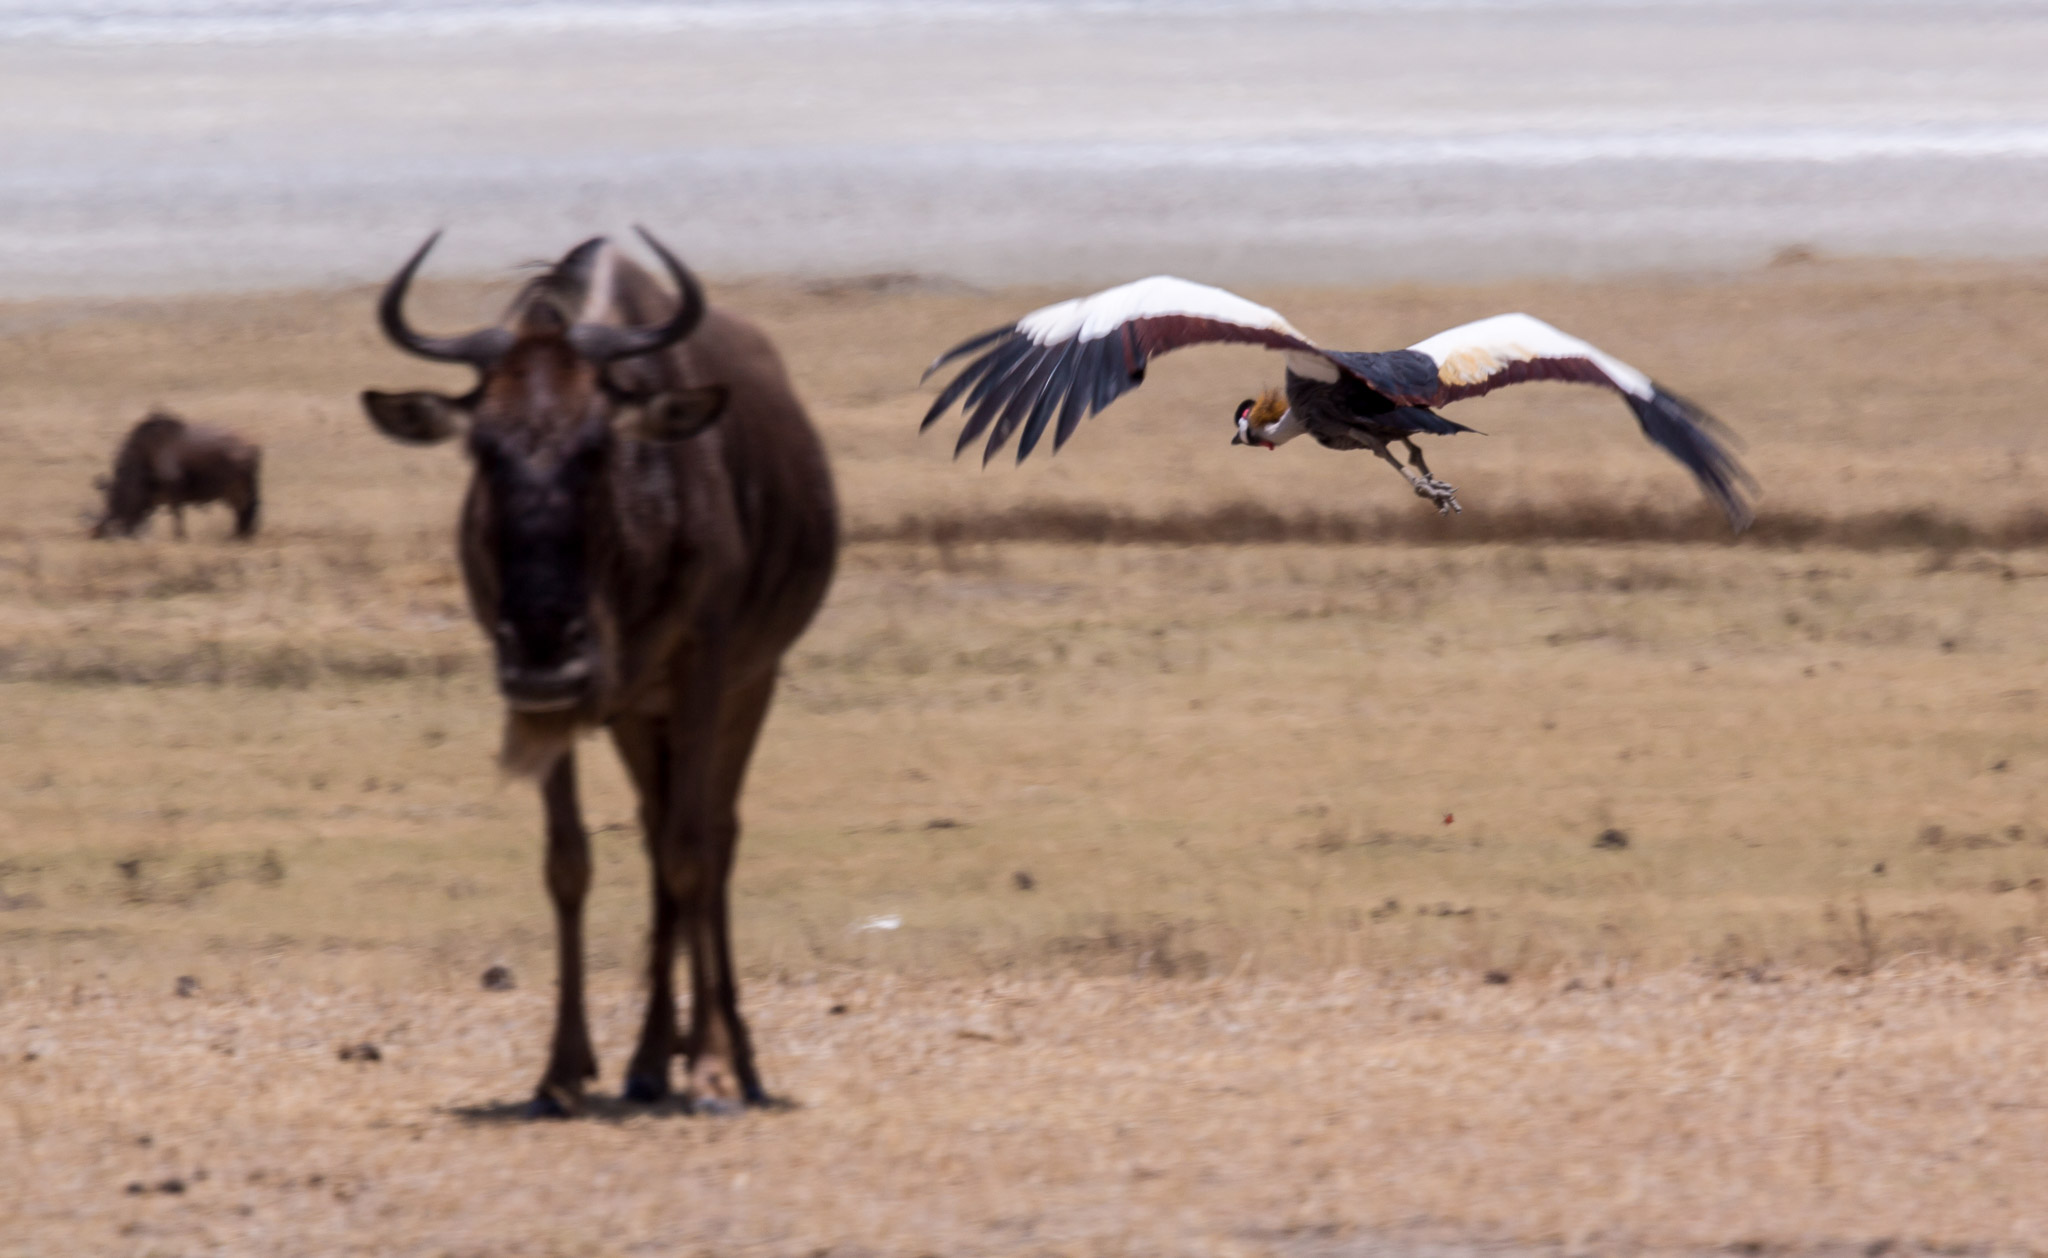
[362, 229, 725, 713]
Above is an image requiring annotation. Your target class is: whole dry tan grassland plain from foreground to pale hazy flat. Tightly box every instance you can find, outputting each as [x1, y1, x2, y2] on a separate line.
[0, 264, 2048, 1256]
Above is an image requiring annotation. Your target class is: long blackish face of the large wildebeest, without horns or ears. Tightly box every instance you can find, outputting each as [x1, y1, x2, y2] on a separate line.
[469, 420, 610, 745]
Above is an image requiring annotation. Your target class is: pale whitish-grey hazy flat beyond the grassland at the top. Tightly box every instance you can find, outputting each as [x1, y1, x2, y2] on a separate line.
[0, 0, 2048, 297]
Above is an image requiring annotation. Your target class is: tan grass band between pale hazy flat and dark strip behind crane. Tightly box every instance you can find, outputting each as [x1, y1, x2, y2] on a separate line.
[12, 262, 2048, 541]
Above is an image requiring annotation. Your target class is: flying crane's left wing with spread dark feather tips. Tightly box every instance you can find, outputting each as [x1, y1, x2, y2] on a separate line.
[920, 275, 1329, 463]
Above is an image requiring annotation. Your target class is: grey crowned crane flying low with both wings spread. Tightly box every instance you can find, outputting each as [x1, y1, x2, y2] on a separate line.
[920, 275, 1755, 531]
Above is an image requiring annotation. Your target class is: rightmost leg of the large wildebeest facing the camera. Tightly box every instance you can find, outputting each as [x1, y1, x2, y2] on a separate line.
[684, 674, 774, 1110]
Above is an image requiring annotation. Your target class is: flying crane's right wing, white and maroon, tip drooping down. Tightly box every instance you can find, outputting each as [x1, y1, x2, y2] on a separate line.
[1323, 313, 1755, 529]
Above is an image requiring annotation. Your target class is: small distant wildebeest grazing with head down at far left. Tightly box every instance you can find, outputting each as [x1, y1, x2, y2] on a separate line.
[92, 410, 262, 541]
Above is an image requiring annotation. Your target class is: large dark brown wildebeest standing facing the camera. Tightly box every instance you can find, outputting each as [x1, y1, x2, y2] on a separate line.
[362, 229, 838, 1115]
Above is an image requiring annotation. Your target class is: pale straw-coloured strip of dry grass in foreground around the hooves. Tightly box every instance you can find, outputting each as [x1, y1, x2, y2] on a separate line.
[12, 957, 2048, 1258]
